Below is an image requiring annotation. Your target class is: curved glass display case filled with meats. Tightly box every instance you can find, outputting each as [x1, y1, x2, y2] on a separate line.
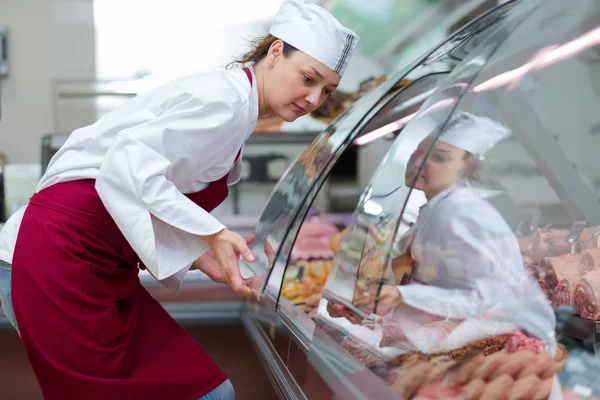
[243, 0, 600, 399]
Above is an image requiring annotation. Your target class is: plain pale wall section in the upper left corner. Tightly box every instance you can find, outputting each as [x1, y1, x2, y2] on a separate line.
[0, 0, 95, 163]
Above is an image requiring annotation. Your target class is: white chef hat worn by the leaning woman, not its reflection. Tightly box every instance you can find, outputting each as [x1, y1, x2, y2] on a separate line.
[269, 0, 360, 76]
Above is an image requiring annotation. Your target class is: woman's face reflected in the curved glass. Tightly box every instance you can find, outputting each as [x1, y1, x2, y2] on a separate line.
[406, 137, 472, 199]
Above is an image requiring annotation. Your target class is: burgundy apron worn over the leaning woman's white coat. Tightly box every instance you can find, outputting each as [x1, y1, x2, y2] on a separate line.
[12, 70, 252, 400]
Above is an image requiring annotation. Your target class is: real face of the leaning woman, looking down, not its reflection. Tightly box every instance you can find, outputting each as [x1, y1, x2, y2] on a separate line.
[263, 41, 341, 122]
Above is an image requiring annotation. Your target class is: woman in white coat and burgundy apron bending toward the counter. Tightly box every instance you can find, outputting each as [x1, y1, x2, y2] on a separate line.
[0, 0, 359, 400]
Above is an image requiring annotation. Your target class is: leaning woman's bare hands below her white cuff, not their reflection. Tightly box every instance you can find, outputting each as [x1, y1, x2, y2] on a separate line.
[194, 229, 255, 296]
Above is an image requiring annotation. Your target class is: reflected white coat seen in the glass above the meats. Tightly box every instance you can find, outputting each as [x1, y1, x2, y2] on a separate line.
[399, 184, 555, 350]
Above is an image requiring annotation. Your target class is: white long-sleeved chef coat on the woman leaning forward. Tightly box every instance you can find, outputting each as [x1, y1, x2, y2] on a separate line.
[0, 68, 258, 291]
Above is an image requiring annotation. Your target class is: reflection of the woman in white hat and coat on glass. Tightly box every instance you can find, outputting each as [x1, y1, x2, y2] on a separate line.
[364, 113, 554, 346]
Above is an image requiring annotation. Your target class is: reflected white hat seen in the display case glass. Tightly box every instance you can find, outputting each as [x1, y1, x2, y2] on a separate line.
[438, 112, 510, 157]
